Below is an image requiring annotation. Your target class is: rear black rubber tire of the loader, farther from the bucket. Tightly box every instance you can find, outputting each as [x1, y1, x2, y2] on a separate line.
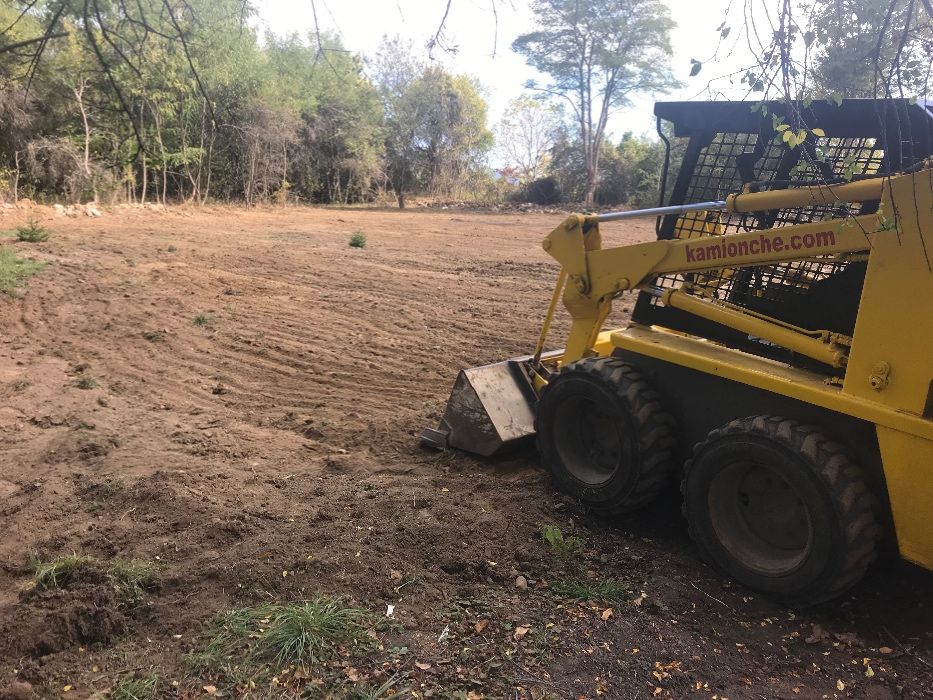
[681, 416, 880, 606]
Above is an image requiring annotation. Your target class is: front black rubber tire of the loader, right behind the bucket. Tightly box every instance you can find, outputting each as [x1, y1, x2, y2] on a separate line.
[535, 357, 675, 515]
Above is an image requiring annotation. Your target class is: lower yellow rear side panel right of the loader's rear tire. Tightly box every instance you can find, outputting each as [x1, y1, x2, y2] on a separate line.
[878, 426, 933, 569]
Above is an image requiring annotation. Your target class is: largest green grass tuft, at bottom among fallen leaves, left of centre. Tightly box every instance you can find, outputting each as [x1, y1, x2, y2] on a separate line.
[188, 595, 375, 682]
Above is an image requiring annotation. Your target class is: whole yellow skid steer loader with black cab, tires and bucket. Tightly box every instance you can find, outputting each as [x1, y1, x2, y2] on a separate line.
[422, 95, 933, 604]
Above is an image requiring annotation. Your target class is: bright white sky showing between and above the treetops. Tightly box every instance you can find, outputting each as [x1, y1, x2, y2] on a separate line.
[256, 0, 748, 138]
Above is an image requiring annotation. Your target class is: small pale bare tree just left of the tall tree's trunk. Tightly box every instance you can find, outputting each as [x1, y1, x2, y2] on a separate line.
[496, 95, 561, 185]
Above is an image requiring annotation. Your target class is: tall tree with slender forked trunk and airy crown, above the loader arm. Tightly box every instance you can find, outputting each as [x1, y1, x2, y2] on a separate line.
[512, 0, 677, 206]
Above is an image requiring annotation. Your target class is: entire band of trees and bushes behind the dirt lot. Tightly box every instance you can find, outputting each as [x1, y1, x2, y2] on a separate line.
[0, 0, 933, 206]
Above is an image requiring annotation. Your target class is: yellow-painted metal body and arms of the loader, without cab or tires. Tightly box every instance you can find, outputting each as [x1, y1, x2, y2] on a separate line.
[533, 168, 933, 569]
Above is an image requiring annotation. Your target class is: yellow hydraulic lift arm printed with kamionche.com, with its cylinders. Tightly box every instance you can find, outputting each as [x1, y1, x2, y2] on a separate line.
[539, 178, 887, 367]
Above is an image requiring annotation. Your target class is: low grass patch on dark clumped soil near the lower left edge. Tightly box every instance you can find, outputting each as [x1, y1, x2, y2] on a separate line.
[26, 553, 159, 605]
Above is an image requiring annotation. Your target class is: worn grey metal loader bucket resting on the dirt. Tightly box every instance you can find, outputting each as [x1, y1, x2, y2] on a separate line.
[421, 358, 536, 457]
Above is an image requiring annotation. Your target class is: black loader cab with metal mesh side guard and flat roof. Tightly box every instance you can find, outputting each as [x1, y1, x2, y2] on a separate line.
[632, 99, 933, 372]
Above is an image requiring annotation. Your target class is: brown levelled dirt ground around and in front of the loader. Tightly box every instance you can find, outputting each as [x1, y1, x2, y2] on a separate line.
[0, 208, 933, 700]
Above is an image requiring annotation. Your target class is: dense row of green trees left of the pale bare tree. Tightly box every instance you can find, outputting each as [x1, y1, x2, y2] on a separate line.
[0, 0, 492, 204]
